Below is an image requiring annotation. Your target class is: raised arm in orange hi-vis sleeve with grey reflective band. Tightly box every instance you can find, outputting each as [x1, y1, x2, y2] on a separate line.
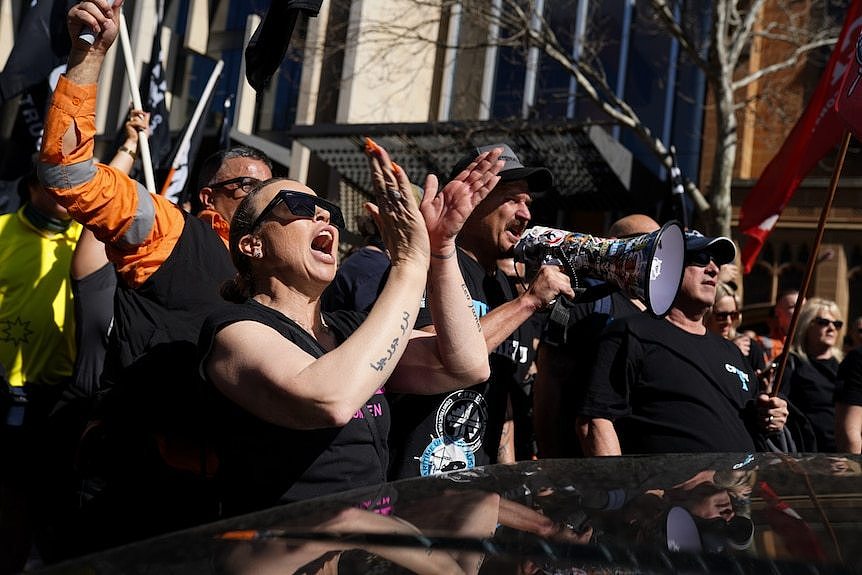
[38, 0, 183, 287]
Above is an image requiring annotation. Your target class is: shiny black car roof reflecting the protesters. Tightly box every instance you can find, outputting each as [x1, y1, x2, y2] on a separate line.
[37, 454, 862, 574]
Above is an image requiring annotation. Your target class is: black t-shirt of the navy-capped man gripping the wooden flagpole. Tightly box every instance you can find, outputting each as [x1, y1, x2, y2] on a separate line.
[578, 314, 758, 453]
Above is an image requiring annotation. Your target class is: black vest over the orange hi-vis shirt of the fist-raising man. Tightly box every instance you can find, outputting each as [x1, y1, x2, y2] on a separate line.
[99, 208, 236, 464]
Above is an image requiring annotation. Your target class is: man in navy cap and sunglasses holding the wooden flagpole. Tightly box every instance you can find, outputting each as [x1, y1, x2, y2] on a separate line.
[578, 231, 788, 455]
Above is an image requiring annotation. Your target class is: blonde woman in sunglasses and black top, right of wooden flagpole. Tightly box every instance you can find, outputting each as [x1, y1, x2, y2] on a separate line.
[781, 298, 844, 453]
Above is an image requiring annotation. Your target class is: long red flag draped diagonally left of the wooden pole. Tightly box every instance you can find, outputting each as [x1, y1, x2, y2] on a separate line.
[739, 0, 862, 273]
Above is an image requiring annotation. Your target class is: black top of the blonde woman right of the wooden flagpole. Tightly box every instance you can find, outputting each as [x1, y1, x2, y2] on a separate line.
[781, 353, 838, 453]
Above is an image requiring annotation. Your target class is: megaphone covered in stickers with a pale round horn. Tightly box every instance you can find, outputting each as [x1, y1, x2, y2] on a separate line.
[515, 222, 685, 317]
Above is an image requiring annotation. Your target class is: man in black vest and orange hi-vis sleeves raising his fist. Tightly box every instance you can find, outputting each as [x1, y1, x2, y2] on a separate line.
[38, 0, 271, 545]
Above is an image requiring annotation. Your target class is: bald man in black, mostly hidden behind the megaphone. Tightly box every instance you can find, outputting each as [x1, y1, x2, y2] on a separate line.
[533, 214, 661, 458]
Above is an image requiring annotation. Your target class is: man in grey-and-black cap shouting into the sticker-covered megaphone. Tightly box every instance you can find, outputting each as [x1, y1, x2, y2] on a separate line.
[390, 144, 574, 479]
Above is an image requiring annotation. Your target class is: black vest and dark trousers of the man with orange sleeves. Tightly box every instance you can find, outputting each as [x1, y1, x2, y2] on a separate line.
[73, 215, 236, 551]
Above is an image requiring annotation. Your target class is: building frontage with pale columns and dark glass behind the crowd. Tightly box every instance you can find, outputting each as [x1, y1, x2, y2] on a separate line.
[0, 0, 862, 328]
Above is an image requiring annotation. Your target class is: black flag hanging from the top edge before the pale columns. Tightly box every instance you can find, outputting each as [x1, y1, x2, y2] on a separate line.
[245, 0, 323, 92]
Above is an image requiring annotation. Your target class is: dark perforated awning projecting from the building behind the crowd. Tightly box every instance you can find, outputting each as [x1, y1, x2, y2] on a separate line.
[288, 120, 667, 212]
